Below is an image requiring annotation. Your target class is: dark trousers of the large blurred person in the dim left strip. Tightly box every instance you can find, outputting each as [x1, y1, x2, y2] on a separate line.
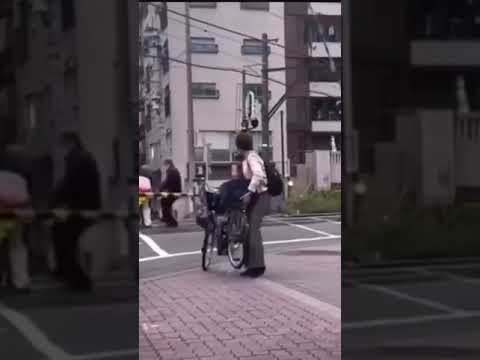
[54, 218, 92, 288]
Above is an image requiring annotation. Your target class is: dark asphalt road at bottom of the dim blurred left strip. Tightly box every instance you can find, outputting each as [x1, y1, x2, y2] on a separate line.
[0, 266, 138, 360]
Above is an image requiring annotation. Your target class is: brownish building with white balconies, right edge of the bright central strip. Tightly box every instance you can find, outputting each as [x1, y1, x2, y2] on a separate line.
[285, 1, 342, 172]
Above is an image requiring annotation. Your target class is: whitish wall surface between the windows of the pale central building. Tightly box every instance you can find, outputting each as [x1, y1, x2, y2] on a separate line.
[167, 2, 286, 188]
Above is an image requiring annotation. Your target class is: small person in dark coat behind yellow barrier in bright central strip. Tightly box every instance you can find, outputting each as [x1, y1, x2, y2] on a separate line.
[160, 160, 182, 227]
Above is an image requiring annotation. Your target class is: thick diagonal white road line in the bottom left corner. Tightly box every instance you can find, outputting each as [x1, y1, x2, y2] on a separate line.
[0, 302, 72, 360]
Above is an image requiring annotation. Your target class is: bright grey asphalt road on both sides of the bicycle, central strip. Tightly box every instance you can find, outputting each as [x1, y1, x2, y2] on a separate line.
[139, 216, 341, 307]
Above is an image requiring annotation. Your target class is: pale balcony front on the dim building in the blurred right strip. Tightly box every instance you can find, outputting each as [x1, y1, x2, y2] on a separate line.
[410, 40, 480, 66]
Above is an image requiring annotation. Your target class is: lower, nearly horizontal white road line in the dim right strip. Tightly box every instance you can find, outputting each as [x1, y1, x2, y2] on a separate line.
[342, 311, 480, 331]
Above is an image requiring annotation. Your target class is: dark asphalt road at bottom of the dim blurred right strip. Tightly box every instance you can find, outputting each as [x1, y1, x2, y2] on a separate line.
[342, 263, 480, 359]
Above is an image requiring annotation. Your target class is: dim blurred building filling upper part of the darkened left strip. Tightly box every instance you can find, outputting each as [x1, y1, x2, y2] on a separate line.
[8, 0, 138, 276]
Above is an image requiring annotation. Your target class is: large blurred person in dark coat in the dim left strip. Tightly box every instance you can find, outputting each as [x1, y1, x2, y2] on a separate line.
[50, 132, 101, 289]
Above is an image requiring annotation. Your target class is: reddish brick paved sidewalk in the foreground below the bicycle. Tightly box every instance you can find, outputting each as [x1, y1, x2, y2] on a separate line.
[139, 268, 341, 360]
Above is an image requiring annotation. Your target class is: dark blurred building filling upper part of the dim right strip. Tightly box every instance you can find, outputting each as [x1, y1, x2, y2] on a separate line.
[344, 0, 480, 225]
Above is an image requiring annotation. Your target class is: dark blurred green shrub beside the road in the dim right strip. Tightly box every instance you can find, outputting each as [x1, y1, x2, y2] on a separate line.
[342, 205, 480, 260]
